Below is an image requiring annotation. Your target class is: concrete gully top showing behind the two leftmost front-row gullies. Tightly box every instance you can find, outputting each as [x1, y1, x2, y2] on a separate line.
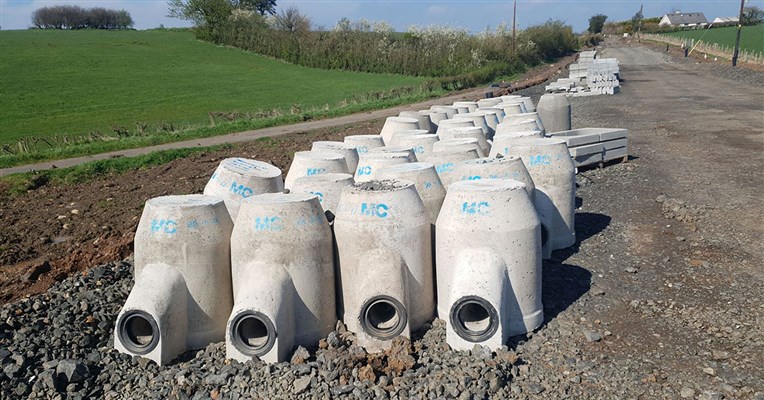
[204, 158, 284, 222]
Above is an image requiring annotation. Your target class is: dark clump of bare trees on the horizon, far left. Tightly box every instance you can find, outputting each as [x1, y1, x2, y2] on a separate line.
[32, 5, 133, 29]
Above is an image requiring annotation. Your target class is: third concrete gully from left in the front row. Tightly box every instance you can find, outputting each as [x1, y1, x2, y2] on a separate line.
[334, 180, 435, 352]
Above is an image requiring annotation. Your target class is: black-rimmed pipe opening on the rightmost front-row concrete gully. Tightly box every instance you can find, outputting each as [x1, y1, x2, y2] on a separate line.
[450, 296, 499, 343]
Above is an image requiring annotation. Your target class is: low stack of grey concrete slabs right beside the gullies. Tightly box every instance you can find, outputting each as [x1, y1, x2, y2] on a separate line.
[547, 128, 629, 167]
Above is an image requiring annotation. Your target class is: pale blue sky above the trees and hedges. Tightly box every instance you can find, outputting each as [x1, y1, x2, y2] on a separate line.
[0, 0, 764, 32]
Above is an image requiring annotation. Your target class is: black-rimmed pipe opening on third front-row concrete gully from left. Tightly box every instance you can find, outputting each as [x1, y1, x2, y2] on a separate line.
[361, 296, 408, 339]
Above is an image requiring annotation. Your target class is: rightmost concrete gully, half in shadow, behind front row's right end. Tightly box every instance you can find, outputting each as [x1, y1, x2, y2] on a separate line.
[508, 138, 576, 258]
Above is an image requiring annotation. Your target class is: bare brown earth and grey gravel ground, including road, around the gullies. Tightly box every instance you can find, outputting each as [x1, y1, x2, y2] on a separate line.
[0, 42, 764, 400]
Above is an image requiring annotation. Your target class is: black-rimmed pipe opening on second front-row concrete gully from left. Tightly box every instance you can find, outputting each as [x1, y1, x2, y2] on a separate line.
[232, 312, 276, 356]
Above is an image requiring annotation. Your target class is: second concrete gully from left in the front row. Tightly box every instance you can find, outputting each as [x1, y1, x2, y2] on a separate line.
[225, 193, 337, 363]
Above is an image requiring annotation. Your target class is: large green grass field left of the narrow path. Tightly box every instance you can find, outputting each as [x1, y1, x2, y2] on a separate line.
[0, 30, 423, 147]
